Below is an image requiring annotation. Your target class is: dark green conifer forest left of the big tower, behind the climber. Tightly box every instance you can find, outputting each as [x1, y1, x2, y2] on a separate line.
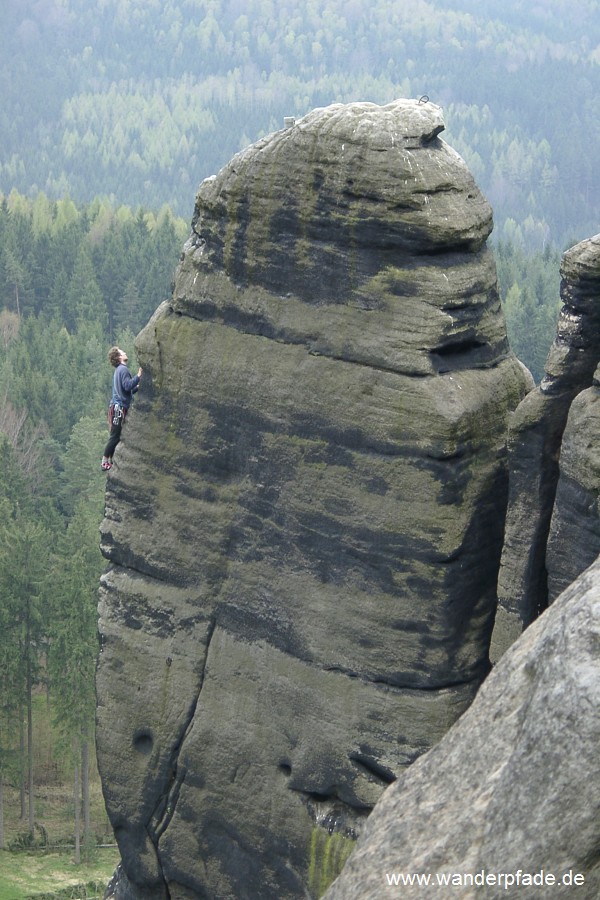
[0, 192, 187, 848]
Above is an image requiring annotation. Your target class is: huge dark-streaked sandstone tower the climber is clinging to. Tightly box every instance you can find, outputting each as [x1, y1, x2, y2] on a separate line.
[97, 101, 529, 900]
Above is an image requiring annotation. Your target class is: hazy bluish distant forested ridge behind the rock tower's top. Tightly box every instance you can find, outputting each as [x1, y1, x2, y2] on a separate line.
[0, 0, 600, 248]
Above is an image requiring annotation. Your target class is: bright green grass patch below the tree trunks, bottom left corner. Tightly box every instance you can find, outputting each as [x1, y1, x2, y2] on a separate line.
[0, 850, 119, 900]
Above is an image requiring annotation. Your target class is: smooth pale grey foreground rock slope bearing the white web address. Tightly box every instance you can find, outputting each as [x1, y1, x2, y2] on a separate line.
[325, 562, 600, 900]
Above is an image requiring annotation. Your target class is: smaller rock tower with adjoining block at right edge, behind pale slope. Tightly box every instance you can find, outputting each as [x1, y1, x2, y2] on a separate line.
[492, 235, 600, 661]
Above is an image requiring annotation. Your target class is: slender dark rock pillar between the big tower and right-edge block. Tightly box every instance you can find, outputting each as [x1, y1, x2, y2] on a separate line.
[490, 235, 600, 661]
